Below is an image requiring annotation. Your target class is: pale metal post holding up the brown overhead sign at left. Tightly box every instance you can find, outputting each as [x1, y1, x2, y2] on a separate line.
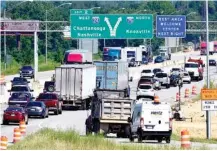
[34, 31, 38, 81]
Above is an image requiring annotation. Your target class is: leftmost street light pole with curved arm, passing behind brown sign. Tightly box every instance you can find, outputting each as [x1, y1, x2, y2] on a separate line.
[3, 0, 32, 70]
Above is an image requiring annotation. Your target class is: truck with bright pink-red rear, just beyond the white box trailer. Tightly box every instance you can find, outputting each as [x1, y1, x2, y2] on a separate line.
[63, 49, 93, 64]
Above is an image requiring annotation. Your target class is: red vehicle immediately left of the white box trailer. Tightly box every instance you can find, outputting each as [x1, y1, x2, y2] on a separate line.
[36, 93, 62, 115]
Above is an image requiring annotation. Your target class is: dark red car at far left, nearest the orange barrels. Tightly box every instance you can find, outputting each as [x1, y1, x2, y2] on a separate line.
[3, 106, 28, 125]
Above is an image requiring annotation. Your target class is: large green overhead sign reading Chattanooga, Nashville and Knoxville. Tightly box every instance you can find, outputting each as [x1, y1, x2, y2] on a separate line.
[70, 14, 153, 39]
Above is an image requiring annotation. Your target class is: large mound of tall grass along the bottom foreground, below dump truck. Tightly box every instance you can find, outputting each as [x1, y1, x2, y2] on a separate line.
[8, 128, 209, 150]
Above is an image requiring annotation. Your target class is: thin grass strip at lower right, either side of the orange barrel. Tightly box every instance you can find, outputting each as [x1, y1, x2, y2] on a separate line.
[171, 134, 217, 144]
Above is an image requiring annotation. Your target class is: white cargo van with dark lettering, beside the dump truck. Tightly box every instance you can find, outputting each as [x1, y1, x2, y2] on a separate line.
[128, 100, 172, 143]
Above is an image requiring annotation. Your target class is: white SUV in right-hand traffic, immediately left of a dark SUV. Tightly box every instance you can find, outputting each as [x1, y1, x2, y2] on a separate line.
[154, 72, 170, 89]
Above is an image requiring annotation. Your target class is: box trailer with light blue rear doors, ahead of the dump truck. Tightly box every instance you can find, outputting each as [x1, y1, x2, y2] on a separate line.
[94, 61, 130, 96]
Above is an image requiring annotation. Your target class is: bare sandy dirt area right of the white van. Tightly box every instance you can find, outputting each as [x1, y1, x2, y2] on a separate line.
[173, 101, 217, 138]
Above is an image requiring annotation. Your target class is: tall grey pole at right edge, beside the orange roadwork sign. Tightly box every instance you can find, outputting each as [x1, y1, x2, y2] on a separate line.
[206, 0, 211, 139]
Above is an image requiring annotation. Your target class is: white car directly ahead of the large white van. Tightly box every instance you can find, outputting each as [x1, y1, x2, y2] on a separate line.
[137, 84, 155, 97]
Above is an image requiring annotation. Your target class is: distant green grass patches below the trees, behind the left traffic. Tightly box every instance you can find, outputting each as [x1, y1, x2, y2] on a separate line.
[2, 54, 102, 75]
